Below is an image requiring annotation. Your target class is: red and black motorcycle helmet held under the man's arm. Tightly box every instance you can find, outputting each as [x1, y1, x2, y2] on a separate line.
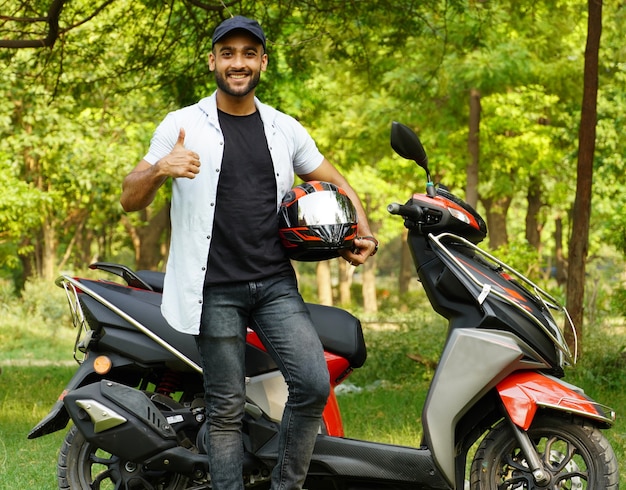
[278, 181, 357, 262]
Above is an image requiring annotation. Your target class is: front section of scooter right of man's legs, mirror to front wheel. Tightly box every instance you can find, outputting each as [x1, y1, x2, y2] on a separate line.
[302, 122, 619, 490]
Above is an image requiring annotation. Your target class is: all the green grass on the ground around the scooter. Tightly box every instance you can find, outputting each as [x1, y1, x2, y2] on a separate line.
[0, 278, 626, 490]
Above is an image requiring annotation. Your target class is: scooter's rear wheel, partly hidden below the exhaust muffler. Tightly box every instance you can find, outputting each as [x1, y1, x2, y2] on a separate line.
[57, 427, 197, 490]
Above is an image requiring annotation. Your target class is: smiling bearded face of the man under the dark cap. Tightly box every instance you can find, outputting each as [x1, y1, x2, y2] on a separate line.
[209, 31, 267, 97]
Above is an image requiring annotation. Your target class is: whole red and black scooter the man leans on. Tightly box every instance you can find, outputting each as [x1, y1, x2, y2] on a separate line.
[29, 123, 619, 490]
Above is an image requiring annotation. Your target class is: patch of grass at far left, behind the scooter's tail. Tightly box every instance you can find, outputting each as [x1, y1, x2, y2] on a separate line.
[0, 283, 76, 490]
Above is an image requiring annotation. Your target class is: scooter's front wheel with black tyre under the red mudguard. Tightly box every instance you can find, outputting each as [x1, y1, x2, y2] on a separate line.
[470, 416, 619, 490]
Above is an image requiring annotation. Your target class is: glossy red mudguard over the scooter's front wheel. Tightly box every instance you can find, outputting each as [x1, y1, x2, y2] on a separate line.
[496, 371, 615, 430]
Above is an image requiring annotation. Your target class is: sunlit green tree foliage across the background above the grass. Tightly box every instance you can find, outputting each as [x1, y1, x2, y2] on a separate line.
[0, 0, 626, 318]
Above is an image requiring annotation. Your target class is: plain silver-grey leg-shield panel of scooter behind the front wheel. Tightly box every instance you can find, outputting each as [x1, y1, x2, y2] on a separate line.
[422, 328, 545, 485]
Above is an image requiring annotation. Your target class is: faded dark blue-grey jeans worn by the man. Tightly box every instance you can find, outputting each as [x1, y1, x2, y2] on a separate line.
[196, 276, 330, 490]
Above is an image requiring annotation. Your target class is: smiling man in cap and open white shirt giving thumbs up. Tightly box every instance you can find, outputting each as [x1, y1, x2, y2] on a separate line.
[121, 16, 377, 490]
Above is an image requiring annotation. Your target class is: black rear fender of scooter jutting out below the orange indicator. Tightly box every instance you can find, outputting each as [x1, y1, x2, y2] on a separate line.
[28, 353, 134, 439]
